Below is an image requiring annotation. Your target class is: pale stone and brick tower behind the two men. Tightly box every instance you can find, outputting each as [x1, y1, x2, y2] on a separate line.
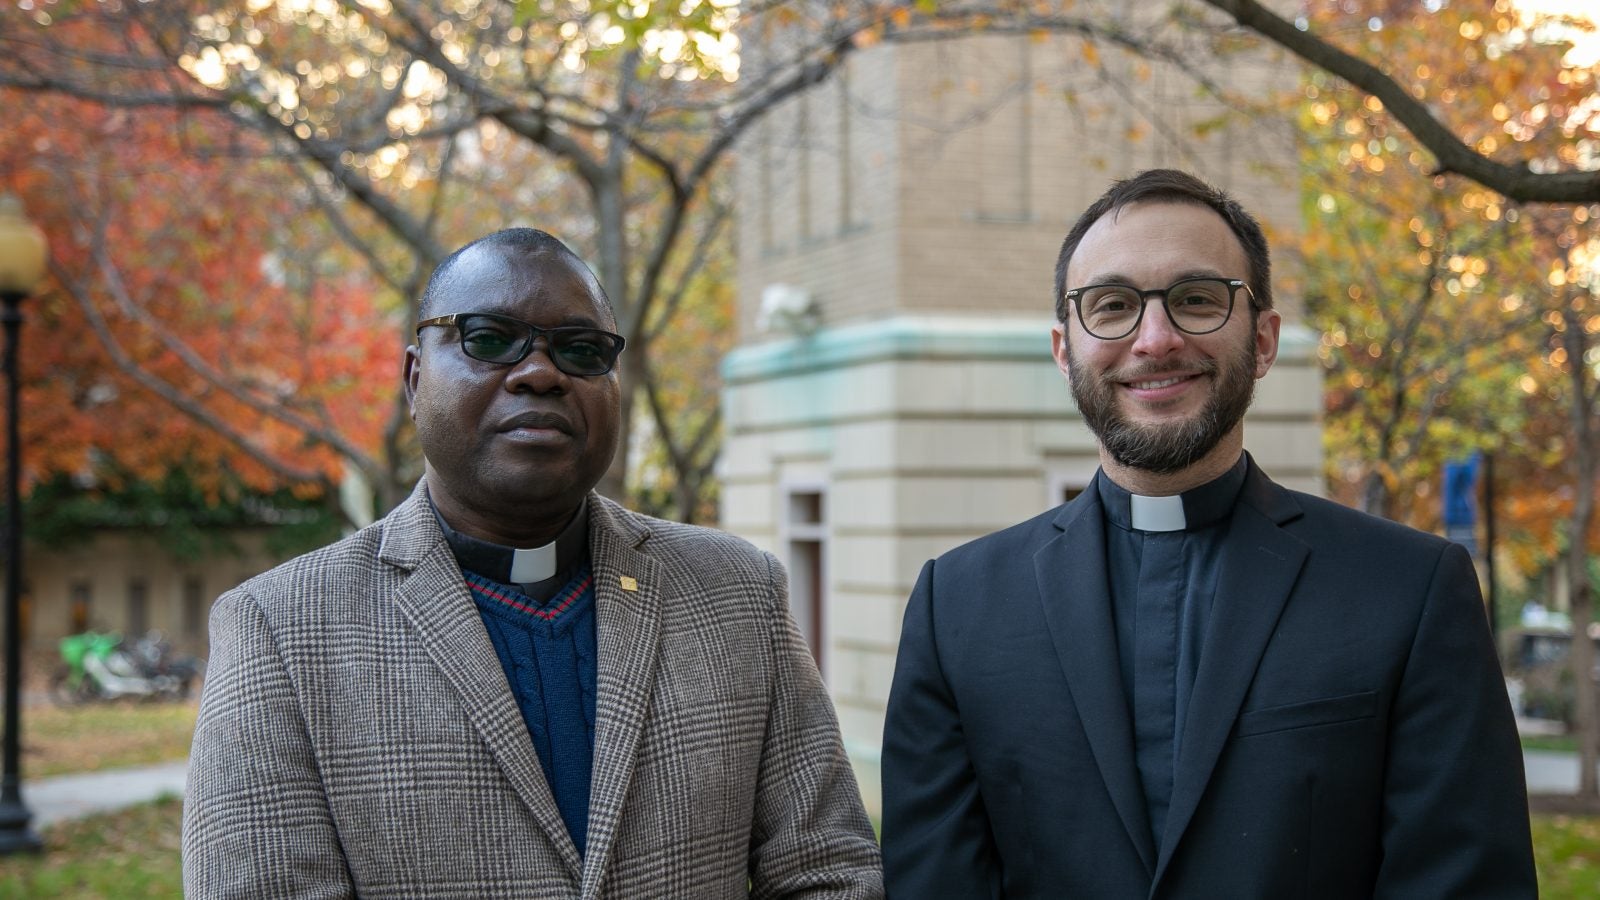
[722, 35, 1322, 807]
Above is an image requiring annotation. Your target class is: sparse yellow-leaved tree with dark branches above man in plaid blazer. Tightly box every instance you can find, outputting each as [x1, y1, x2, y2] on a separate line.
[0, 0, 902, 518]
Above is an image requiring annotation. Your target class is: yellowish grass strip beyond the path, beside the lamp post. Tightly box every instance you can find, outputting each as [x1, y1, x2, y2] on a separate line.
[22, 701, 198, 778]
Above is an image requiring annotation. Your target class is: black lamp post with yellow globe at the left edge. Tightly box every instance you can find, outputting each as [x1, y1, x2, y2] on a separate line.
[0, 194, 45, 855]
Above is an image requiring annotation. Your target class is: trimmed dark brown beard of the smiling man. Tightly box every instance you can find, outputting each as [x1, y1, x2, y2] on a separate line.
[1067, 333, 1256, 476]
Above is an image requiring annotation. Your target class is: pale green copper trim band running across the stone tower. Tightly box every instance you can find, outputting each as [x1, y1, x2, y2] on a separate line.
[722, 315, 1317, 384]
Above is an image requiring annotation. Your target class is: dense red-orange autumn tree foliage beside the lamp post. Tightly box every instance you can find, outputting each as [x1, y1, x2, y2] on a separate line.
[0, 84, 398, 525]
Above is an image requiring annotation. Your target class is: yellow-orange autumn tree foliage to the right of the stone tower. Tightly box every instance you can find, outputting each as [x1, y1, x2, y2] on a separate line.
[1296, 2, 1600, 796]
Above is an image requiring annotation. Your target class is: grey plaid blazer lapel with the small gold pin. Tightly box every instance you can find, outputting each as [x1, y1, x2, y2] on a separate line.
[582, 495, 664, 897]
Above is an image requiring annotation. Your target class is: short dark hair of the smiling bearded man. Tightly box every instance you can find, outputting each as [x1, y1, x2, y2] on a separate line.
[1056, 168, 1272, 322]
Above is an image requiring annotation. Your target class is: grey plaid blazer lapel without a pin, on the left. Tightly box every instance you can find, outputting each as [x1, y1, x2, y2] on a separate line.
[378, 485, 581, 881]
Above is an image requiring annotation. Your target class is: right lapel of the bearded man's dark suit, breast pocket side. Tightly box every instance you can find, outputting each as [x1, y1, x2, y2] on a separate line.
[1155, 461, 1310, 882]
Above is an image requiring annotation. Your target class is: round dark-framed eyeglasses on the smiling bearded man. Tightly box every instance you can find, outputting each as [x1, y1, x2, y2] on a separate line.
[1066, 279, 1256, 341]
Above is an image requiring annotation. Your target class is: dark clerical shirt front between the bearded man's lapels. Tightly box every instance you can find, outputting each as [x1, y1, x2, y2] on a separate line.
[1094, 453, 1246, 847]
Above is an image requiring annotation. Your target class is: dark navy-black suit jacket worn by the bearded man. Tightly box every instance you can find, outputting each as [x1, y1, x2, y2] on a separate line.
[883, 463, 1536, 900]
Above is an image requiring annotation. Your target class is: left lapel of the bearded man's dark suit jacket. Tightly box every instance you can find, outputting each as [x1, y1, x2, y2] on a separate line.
[1034, 490, 1155, 871]
